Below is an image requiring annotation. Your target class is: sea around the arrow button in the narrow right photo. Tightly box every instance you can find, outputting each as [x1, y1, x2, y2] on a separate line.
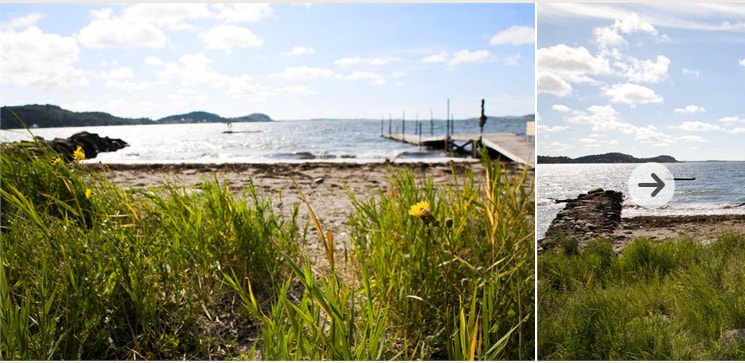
[536, 161, 745, 238]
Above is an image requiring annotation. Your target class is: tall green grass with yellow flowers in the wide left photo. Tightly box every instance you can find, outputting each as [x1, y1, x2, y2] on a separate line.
[0, 137, 535, 360]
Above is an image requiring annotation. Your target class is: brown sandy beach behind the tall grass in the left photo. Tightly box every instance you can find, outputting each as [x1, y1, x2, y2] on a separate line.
[88, 159, 494, 265]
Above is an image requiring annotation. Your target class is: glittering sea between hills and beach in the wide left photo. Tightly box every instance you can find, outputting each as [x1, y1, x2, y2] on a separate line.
[0, 119, 525, 164]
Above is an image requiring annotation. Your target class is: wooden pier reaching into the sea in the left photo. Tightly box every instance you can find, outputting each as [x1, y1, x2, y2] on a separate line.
[383, 133, 535, 167]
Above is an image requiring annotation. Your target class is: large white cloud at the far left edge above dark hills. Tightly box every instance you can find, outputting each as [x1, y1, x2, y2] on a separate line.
[0, 26, 88, 88]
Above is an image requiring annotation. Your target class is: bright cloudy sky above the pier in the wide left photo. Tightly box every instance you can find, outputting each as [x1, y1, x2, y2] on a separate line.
[0, 3, 535, 120]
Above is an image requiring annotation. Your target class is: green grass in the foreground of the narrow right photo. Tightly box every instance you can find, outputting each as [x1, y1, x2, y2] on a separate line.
[538, 233, 745, 360]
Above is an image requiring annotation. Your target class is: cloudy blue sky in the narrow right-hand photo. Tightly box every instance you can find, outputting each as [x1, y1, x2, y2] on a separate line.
[536, 4, 745, 160]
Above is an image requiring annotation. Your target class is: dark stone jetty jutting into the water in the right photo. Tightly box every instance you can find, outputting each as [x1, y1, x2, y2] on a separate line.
[538, 188, 623, 250]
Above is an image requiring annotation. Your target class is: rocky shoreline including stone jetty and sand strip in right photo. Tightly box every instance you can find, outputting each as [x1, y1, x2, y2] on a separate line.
[537, 189, 745, 252]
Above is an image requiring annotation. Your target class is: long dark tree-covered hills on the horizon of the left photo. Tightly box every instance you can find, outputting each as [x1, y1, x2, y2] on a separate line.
[0, 105, 272, 129]
